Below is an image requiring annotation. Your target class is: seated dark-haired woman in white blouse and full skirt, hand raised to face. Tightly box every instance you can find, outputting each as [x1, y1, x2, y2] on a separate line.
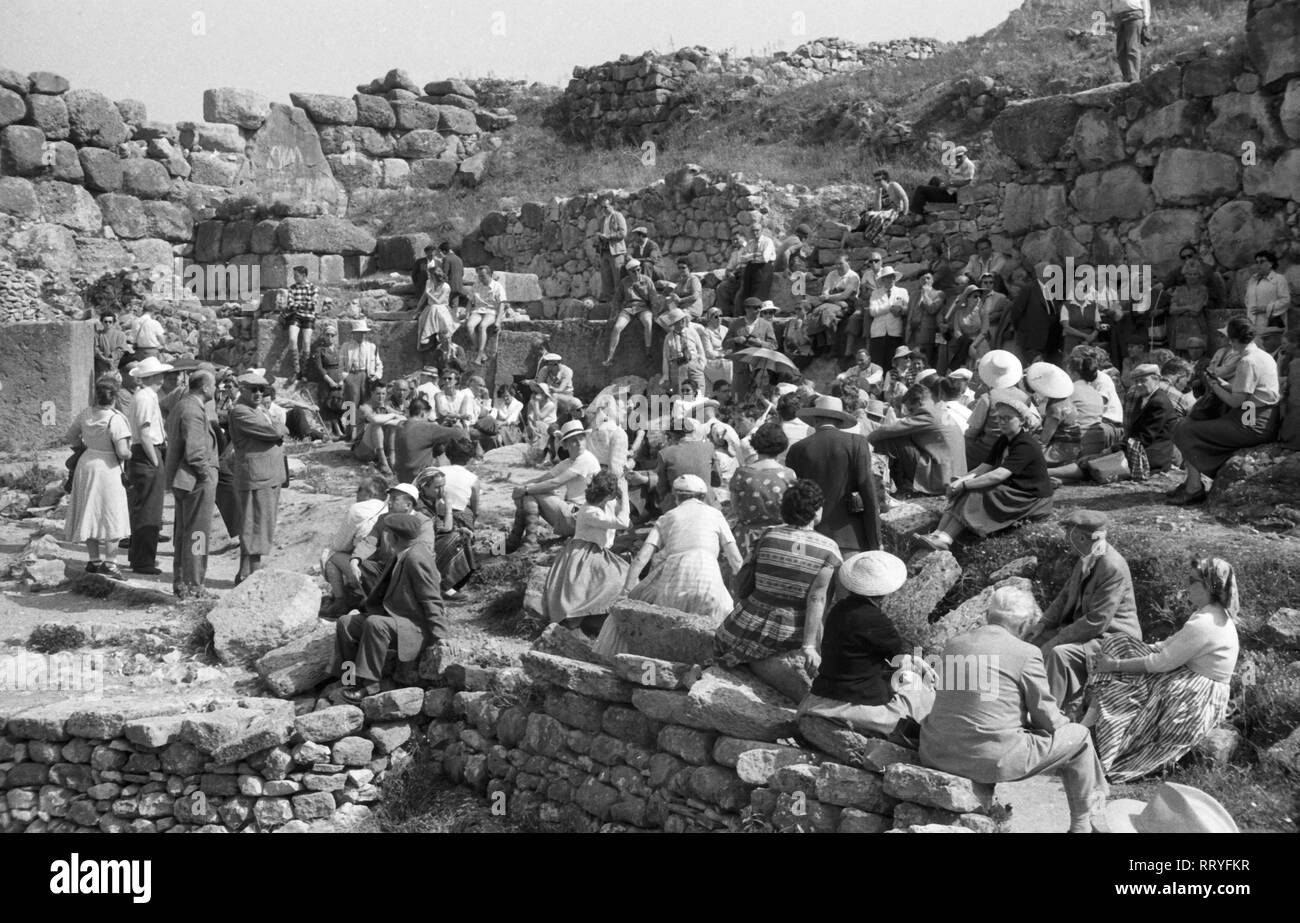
[542, 471, 631, 637]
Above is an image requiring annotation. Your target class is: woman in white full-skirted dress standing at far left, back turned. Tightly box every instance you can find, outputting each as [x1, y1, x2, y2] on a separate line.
[64, 376, 131, 580]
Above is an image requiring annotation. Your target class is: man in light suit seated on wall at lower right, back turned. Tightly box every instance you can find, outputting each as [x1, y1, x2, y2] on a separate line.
[920, 586, 1109, 833]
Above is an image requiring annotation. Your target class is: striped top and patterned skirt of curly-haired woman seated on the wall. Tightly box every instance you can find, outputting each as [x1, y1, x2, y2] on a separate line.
[714, 525, 841, 667]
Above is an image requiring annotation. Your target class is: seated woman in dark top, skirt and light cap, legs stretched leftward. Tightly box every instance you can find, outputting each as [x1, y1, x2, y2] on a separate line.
[917, 398, 1052, 550]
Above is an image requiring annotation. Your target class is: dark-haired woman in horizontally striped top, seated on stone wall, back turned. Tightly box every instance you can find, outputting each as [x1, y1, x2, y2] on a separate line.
[714, 478, 841, 702]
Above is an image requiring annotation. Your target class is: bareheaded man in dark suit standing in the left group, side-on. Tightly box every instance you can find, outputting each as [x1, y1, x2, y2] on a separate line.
[163, 369, 218, 599]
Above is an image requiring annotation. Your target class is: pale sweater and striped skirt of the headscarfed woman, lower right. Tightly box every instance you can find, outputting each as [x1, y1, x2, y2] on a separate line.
[1087, 611, 1238, 783]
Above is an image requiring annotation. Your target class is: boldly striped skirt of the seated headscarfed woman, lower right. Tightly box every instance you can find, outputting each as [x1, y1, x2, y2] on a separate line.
[1087, 634, 1229, 783]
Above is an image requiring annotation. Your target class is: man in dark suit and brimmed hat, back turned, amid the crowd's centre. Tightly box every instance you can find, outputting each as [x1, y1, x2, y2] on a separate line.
[785, 398, 880, 554]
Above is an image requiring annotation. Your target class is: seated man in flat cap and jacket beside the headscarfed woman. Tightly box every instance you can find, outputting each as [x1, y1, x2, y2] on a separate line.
[1026, 510, 1141, 712]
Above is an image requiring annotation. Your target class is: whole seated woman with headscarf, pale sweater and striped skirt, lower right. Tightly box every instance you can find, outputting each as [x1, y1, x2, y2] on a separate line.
[1083, 556, 1242, 783]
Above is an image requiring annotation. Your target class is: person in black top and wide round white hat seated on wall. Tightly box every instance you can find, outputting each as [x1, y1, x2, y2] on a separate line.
[800, 551, 935, 740]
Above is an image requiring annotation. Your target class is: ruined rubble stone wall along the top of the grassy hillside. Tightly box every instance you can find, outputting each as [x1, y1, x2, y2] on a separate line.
[553, 38, 941, 146]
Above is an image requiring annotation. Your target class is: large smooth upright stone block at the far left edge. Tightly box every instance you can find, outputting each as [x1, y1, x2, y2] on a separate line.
[0, 321, 95, 451]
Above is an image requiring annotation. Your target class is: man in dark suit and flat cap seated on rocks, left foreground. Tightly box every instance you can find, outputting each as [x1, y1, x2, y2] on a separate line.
[330, 512, 447, 702]
